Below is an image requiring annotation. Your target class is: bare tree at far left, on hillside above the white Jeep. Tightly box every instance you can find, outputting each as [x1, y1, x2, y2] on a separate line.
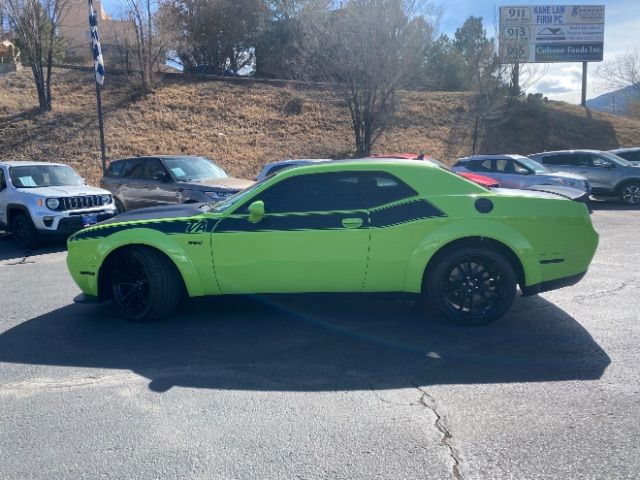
[4, 0, 67, 111]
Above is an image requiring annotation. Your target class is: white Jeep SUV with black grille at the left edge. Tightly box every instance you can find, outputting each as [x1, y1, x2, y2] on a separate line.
[0, 162, 116, 248]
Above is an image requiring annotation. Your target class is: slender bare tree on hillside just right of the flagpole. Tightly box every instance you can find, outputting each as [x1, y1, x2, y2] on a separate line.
[124, 0, 167, 92]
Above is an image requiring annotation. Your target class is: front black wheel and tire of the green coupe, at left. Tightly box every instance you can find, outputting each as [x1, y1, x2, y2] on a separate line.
[109, 246, 184, 322]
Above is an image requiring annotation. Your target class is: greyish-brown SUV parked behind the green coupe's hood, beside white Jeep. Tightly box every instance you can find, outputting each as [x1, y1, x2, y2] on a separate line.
[100, 155, 253, 212]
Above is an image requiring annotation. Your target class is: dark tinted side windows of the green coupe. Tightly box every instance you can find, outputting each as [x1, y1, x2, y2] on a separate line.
[244, 172, 417, 213]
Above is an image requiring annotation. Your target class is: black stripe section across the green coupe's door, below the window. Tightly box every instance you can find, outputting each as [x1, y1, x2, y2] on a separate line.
[215, 212, 368, 233]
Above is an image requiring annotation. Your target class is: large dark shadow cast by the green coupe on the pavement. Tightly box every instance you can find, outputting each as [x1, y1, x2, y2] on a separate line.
[0, 295, 610, 391]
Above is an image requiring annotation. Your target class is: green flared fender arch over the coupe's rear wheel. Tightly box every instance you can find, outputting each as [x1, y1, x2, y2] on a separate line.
[405, 219, 541, 293]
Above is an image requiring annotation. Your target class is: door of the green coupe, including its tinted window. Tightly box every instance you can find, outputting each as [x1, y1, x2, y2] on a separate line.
[212, 172, 370, 293]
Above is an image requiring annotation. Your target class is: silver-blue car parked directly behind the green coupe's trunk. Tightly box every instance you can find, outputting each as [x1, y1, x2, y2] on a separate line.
[453, 155, 589, 192]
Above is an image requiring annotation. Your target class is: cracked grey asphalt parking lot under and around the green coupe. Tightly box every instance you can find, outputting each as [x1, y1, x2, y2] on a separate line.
[0, 202, 640, 480]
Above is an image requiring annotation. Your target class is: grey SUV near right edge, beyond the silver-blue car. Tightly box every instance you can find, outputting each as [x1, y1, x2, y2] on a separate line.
[529, 150, 640, 205]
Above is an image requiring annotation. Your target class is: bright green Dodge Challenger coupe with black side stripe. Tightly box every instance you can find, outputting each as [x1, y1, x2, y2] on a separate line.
[67, 159, 598, 325]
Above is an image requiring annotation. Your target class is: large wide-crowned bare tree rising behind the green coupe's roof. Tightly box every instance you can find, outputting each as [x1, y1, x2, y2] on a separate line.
[297, 0, 438, 156]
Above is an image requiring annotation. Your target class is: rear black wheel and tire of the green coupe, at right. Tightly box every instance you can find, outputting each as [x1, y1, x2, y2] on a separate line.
[425, 246, 517, 326]
